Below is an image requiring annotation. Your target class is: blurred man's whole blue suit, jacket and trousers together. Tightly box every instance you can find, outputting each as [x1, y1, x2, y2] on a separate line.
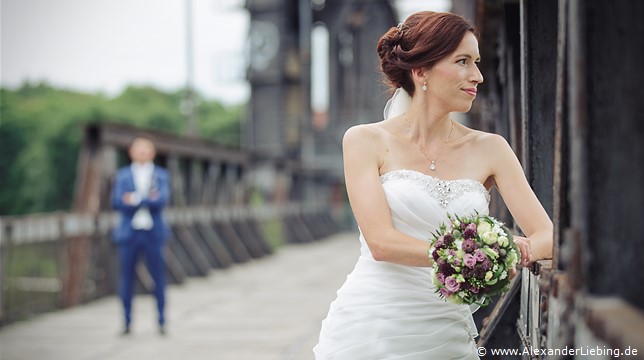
[112, 166, 170, 329]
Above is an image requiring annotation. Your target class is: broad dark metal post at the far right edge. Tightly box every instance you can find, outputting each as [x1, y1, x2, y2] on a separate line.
[573, 0, 644, 310]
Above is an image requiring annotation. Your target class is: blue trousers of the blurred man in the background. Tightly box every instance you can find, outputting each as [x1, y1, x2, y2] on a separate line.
[119, 230, 165, 327]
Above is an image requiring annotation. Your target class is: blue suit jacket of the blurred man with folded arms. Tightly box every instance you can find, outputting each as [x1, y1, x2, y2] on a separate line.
[112, 166, 170, 243]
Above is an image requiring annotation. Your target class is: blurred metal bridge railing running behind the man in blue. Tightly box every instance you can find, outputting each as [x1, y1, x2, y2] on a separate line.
[0, 203, 341, 323]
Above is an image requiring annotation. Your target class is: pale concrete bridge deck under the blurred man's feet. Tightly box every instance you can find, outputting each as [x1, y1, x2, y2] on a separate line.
[0, 232, 359, 360]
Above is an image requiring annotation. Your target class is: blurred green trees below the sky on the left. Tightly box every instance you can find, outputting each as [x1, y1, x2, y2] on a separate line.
[0, 84, 244, 215]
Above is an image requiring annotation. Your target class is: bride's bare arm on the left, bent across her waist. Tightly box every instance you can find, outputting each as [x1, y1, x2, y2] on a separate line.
[342, 125, 432, 266]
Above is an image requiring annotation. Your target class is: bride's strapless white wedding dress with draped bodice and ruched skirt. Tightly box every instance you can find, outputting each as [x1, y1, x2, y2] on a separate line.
[313, 170, 489, 360]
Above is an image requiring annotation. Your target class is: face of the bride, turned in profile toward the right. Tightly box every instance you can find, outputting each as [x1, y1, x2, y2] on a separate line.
[426, 31, 483, 112]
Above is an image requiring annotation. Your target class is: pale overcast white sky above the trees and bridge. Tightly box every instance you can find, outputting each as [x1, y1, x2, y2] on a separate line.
[0, 0, 449, 104]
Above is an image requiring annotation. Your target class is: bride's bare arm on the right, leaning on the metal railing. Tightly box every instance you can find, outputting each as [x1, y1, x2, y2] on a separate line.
[486, 135, 553, 265]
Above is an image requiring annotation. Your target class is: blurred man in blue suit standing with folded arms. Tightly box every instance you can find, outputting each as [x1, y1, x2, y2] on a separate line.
[112, 137, 170, 335]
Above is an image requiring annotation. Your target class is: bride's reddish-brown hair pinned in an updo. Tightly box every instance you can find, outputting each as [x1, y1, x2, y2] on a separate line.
[377, 11, 475, 96]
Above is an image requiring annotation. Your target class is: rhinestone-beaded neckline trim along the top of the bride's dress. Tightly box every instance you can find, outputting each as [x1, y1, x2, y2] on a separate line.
[380, 170, 490, 207]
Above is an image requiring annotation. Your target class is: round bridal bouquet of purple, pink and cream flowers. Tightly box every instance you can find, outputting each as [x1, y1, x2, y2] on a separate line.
[429, 214, 520, 306]
